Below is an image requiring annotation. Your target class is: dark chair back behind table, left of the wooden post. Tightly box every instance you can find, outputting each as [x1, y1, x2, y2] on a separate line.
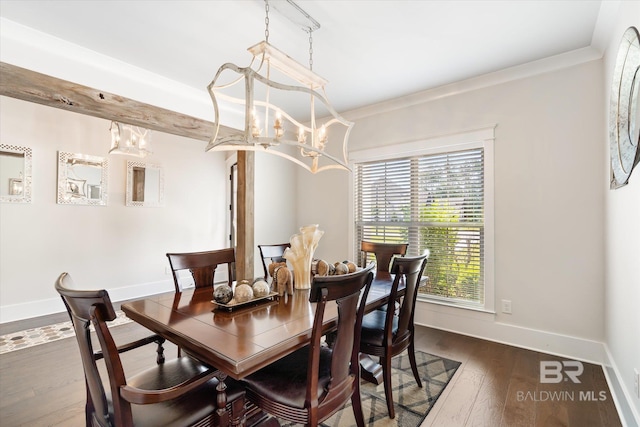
[167, 248, 236, 292]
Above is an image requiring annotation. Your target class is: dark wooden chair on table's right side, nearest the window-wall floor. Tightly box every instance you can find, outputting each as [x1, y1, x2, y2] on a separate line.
[360, 255, 427, 418]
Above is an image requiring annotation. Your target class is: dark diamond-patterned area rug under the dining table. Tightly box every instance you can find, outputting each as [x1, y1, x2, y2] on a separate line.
[280, 351, 460, 427]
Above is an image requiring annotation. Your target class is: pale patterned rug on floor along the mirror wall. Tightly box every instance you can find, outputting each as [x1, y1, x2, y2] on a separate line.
[0, 310, 131, 354]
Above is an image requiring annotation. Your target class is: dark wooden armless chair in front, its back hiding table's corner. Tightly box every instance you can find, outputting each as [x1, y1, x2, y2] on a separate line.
[242, 263, 374, 427]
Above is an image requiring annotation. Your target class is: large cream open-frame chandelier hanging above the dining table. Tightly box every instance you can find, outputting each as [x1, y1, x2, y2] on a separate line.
[205, 0, 353, 173]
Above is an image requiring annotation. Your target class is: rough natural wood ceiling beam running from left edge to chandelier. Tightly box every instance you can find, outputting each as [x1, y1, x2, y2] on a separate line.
[0, 62, 232, 141]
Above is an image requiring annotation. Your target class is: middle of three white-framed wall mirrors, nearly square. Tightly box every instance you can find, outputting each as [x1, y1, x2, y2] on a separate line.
[58, 151, 108, 206]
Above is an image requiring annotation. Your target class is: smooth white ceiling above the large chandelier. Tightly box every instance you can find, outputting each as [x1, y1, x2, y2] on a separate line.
[0, 0, 606, 112]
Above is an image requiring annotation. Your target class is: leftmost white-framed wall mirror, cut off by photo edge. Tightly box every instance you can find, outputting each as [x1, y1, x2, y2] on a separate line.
[0, 144, 31, 203]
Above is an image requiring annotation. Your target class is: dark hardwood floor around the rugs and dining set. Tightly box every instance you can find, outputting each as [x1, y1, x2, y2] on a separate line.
[0, 317, 621, 427]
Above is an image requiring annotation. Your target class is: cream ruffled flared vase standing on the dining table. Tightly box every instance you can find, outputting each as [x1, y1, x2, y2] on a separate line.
[283, 224, 324, 289]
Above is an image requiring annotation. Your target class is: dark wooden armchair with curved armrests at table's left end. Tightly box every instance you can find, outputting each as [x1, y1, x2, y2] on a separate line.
[55, 273, 244, 427]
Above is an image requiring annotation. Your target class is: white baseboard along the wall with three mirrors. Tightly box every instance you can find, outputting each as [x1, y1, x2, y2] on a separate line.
[0, 279, 174, 323]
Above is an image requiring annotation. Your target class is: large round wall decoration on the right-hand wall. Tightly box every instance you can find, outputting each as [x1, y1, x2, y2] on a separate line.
[609, 27, 640, 188]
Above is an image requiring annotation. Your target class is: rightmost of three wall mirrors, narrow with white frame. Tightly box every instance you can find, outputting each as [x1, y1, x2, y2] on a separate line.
[126, 161, 164, 207]
